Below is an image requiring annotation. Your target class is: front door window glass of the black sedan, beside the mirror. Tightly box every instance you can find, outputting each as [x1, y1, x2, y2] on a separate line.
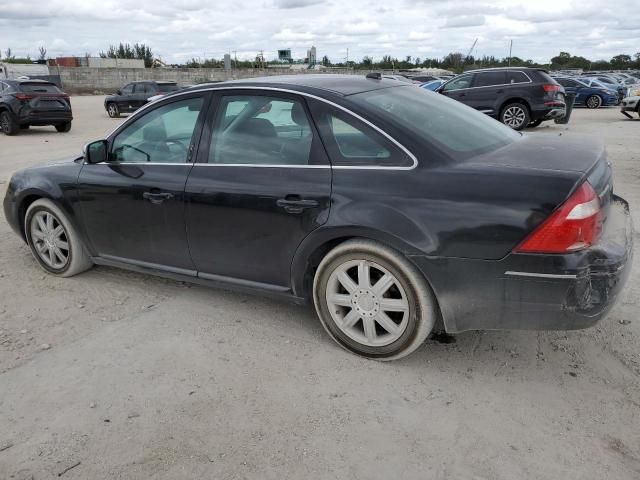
[110, 97, 203, 163]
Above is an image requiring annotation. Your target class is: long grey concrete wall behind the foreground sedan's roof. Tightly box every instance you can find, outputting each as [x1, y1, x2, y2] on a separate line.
[49, 66, 364, 94]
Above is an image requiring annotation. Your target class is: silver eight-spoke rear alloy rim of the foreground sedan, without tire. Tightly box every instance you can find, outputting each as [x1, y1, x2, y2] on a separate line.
[326, 260, 410, 347]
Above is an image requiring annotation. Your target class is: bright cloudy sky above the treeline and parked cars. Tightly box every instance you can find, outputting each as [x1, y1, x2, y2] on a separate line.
[0, 0, 640, 63]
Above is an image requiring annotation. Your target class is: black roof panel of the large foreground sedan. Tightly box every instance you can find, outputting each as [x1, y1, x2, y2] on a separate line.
[191, 73, 402, 96]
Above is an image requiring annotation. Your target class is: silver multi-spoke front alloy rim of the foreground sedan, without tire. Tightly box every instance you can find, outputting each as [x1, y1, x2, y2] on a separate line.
[30, 210, 70, 270]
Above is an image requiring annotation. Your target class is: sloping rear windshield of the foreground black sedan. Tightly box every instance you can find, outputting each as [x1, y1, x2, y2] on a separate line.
[350, 86, 520, 160]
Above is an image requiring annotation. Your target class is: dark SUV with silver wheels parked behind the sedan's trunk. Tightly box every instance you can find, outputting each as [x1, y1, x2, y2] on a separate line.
[438, 68, 566, 130]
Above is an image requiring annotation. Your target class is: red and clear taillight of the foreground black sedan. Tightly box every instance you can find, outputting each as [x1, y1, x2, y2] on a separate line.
[514, 182, 602, 253]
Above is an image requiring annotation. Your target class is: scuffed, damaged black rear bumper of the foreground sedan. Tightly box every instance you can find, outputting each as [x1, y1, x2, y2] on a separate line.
[412, 197, 633, 333]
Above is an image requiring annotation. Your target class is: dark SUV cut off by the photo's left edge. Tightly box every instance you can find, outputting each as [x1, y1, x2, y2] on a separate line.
[0, 79, 73, 135]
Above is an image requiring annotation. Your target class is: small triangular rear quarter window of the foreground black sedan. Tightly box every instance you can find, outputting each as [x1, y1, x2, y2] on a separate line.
[313, 105, 413, 167]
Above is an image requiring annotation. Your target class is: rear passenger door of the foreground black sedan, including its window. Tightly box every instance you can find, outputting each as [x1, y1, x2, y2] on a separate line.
[186, 90, 331, 288]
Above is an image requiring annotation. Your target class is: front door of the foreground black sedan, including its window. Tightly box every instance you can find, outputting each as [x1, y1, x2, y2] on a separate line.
[78, 94, 208, 273]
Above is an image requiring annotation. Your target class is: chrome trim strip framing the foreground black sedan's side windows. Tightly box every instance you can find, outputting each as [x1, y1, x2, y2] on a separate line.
[100, 85, 418, 170]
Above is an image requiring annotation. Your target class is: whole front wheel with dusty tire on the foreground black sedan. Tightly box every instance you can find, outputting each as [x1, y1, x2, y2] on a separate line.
[24, 198, 93, 277]
